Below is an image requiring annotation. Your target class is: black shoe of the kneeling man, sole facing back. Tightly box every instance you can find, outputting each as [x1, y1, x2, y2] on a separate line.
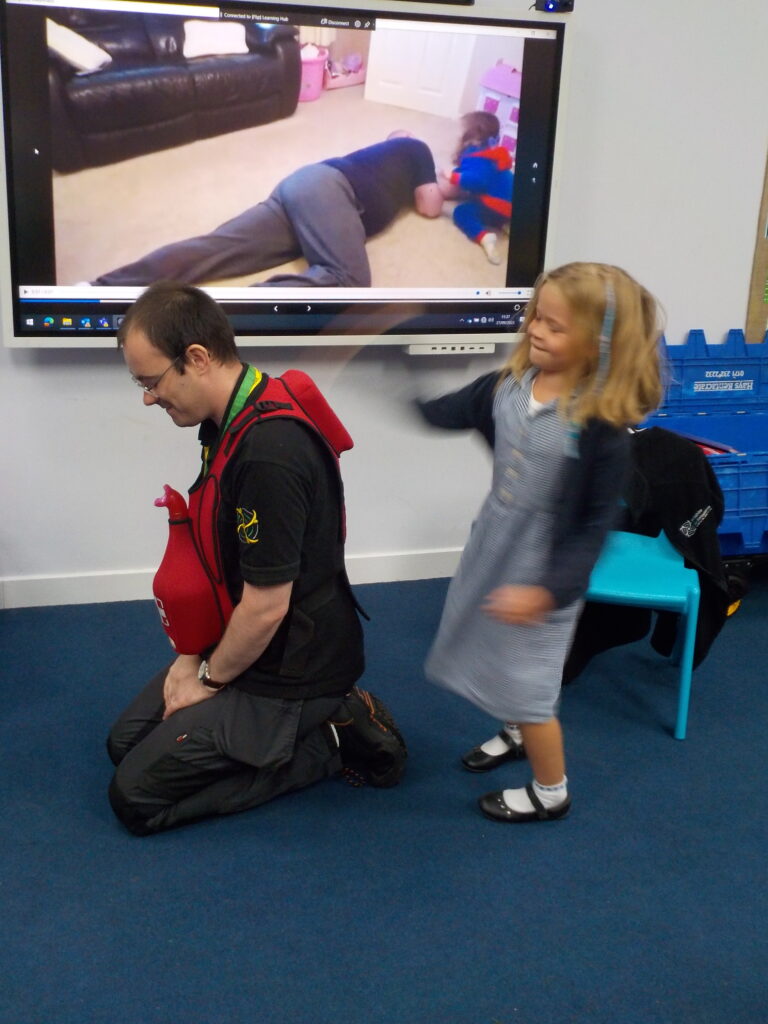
[331, 686, 408, 787]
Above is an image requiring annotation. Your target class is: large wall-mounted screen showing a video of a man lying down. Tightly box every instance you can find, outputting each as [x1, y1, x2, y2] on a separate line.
[0, 0, 564, 346]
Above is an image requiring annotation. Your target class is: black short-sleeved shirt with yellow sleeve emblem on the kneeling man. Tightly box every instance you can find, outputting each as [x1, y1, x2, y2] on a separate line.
[210, 419, 364, 697]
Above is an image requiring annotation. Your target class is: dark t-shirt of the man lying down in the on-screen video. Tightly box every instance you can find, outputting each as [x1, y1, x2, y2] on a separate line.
[324, 138, 437, 238]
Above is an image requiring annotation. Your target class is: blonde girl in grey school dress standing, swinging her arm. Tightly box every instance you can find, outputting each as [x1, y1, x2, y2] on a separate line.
[420, 263, 662, 822]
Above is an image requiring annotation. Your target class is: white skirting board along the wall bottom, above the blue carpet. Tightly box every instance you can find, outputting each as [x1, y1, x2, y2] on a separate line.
[0, 549, 461, 608]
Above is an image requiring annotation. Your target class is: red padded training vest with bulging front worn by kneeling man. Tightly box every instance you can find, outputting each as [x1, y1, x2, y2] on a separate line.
[153, 370, 353, 654]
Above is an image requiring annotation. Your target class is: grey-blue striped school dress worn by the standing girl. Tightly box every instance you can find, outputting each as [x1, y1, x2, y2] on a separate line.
[425, 371, 583, 722]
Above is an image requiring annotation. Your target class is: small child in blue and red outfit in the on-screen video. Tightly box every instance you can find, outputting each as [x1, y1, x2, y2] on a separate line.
[438, 111, 514, 264]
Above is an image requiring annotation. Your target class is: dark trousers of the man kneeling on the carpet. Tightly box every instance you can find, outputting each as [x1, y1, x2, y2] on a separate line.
[108, 669, 342, 836]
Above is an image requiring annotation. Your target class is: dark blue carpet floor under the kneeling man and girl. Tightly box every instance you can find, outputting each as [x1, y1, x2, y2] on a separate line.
[0, 580, 768, 1024]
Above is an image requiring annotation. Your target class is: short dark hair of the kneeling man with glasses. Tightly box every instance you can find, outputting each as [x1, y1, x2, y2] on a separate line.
[118, 281, 240, 373]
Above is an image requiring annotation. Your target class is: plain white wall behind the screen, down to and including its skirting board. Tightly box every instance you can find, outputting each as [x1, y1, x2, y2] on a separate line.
[0, 0, 768, 607]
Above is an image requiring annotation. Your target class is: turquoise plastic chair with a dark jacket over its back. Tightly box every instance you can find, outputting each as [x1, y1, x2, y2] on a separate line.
[586, 530, 699, 739]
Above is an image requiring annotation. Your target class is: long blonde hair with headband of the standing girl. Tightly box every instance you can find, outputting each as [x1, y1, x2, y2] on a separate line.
[501, 263, 664, 427]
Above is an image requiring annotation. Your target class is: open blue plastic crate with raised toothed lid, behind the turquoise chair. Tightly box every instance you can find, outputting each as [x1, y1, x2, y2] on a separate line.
[645, 331, 768, 557]
